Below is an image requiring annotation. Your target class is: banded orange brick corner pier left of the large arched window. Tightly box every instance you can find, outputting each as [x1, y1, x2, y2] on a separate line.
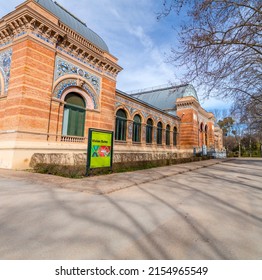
[3, 39, 54, 140]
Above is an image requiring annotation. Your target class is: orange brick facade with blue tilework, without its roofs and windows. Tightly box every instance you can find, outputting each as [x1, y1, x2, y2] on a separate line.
[0, 0, 222, 168]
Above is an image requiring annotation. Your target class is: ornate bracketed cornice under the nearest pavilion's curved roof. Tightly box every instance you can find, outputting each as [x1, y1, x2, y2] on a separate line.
[0, 1, 122, 79]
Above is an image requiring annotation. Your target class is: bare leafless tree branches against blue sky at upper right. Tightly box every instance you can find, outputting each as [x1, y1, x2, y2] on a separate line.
[159, 0, 262, 108]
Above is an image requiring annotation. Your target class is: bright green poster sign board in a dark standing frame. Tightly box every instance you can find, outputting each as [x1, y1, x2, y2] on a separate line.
[87, 128, 113, 173]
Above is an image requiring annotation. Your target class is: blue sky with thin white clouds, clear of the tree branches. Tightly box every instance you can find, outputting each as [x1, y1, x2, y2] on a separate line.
[0, 0, 228, 110]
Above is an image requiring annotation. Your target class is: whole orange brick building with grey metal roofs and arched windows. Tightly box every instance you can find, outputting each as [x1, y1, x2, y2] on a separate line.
[0, 0, 223, 169]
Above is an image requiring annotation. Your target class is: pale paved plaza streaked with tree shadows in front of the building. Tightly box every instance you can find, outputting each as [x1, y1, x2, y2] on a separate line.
[0, 159, 262, 259]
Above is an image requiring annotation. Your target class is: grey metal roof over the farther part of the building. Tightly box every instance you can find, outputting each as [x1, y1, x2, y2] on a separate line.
[131, 85, 199, 113]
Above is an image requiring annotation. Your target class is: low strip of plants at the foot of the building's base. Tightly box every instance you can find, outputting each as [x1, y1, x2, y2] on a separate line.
[34, 156, 211, 179]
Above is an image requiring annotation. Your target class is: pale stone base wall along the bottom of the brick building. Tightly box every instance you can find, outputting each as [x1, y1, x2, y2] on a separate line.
[0, 141, 193, 170]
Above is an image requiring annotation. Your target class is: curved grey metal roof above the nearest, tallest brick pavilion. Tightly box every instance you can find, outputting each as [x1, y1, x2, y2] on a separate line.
[35, 0, 109, 52]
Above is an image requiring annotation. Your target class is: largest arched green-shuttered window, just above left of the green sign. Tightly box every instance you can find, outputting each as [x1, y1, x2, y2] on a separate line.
[62, 92, 86, 136]
